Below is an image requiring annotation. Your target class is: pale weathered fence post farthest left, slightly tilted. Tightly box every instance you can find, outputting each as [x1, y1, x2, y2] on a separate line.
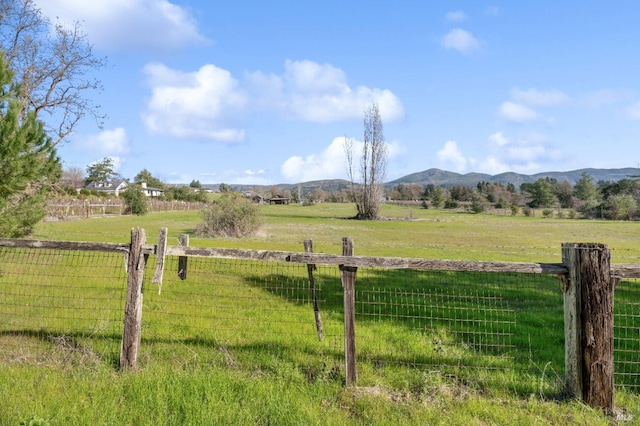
[120, 228, 147, 369]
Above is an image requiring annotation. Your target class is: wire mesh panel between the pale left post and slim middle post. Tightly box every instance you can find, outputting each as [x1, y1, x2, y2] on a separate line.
[141, 257, 343, 374]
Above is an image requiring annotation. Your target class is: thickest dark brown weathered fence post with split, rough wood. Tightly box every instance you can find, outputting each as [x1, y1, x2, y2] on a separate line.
[562, 243, 615, 414]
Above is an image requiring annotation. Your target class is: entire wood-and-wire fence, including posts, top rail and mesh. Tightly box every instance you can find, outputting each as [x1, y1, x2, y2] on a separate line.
[0, 230, 640, 407]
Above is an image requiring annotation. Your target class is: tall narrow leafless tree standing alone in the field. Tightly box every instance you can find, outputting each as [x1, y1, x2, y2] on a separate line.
[344, 102, 388, 220]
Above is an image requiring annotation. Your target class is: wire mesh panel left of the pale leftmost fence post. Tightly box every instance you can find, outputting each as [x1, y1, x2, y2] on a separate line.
[0, 247, 127, 363]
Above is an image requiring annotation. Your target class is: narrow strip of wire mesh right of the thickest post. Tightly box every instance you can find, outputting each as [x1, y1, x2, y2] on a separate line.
[613, 279, 640, 391]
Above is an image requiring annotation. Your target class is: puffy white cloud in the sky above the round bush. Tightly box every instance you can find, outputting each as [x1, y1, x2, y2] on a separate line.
[142, 64, 247, 142]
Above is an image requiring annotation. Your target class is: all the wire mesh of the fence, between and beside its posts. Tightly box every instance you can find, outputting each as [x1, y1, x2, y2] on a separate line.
[0, 241, 640, 392]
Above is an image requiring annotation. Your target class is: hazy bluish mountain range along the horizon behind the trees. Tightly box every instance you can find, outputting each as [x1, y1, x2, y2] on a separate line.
[208, 167, 640, 193]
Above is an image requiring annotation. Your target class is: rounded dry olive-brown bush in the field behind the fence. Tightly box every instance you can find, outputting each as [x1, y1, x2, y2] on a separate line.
[196, 192, 262, 238]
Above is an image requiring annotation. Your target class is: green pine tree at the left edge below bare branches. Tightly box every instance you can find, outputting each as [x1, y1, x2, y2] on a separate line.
[0, 55, 62, 238]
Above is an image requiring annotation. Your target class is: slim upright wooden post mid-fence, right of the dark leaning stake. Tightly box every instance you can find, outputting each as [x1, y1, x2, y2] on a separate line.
[340, 237, 358, 386]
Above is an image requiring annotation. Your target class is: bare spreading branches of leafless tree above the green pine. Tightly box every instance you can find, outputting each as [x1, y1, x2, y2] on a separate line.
[0, 0, 106, 146]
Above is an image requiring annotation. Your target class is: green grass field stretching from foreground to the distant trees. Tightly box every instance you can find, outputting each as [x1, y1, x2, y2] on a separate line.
[0, 204, 640, 425]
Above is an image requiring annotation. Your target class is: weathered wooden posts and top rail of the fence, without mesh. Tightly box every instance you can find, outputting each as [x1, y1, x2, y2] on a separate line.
[0, 228, 640, 412]
